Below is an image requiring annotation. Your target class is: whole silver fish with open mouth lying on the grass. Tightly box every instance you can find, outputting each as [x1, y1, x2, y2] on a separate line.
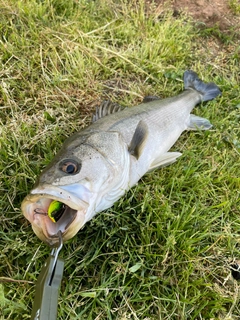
[21, 70, 221, 246]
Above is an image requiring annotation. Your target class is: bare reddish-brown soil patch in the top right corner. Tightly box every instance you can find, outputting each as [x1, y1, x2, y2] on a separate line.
[155, 0, 240, 33]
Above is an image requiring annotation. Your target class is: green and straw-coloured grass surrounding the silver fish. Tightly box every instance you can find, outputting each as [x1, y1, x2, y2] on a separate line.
[0, 0, 240, 320]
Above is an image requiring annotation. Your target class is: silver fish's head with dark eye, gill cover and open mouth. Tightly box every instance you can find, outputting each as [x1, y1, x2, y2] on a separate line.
[21, 133, 127, 245]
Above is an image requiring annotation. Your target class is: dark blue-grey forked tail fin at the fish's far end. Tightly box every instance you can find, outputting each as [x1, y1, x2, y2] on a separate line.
[183, 70, 221, 101]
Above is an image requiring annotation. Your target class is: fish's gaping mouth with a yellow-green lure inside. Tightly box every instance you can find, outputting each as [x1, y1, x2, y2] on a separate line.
[22, 189, 88, 245]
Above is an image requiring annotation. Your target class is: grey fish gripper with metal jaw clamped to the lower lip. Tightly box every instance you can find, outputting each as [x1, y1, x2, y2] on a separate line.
[31, 231, 64, 320]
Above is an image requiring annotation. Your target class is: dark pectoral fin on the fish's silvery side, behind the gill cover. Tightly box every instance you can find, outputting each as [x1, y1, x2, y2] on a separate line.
[128, 120, 148, 159]
